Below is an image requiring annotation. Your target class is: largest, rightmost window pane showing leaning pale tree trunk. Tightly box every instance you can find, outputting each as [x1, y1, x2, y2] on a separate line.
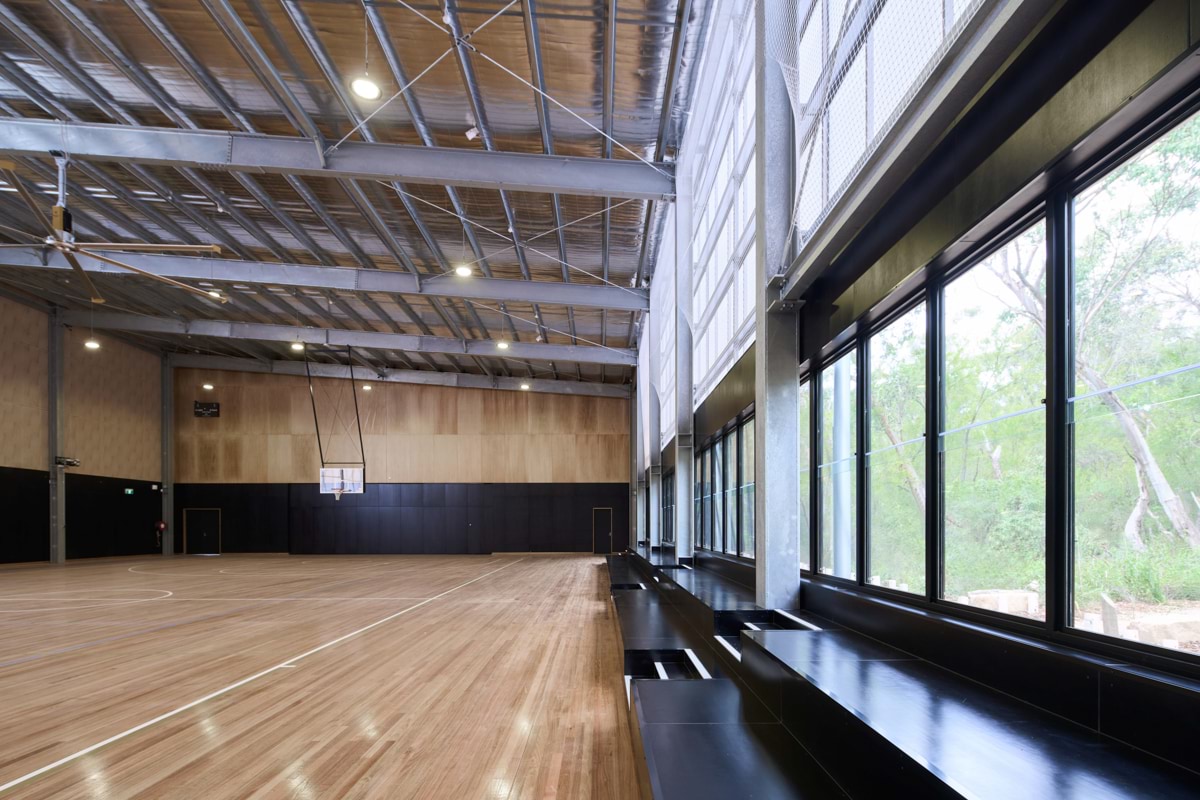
[1072, 116, 1200, 652]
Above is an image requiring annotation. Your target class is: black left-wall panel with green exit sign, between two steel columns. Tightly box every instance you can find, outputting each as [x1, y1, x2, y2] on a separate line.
[64, 473, 162, 559]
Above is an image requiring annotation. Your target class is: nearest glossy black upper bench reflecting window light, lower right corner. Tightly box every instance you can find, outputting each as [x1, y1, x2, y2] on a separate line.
[742, 630, 1200, 800]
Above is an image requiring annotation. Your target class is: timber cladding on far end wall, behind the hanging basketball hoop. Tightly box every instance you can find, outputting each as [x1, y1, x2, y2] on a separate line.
[175, 369, 629, 483]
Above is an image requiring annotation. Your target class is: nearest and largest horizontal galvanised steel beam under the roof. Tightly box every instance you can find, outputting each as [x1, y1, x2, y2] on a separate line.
[0, 119, 674, 200]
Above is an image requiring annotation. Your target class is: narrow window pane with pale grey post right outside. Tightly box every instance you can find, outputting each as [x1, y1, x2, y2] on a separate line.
[817, 350, 858, 579]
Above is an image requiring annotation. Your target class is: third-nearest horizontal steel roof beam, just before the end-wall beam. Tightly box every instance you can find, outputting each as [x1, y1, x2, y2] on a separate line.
[62, 311, 637, 367]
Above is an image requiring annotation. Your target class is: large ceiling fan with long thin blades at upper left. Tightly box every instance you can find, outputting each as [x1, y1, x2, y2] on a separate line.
[0, 151, 229, 303]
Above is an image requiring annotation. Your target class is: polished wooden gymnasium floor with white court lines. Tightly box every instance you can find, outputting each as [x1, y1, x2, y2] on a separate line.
[0, 555, 637, 800]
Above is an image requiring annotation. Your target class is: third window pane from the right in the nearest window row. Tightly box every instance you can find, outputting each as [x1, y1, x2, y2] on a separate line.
[866, 303, 926, 594]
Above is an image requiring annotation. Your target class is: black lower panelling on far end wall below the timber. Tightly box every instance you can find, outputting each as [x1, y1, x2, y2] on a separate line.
[175, 483, 629, 554]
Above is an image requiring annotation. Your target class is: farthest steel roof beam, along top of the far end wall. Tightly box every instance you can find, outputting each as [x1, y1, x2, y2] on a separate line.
[169, 354, 629, 398]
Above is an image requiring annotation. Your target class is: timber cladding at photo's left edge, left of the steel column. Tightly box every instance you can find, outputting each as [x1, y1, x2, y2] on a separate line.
[0, 299, 49, 471]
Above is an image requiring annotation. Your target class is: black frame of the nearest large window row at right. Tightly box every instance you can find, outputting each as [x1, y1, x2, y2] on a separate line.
[797, 78, 1200, 678]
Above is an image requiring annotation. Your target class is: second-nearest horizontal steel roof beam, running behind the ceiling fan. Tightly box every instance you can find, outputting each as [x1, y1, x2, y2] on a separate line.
[0, 247, 650, 311]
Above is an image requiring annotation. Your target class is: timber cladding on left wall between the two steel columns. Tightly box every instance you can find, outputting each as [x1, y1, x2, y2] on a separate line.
[62, 329, 162, 481]
